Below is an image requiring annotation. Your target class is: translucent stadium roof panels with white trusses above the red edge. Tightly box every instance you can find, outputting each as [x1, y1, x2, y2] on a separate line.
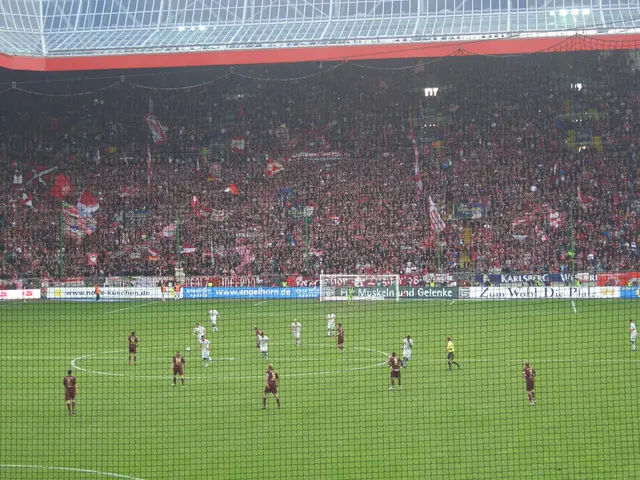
[0, 0, 640, 70]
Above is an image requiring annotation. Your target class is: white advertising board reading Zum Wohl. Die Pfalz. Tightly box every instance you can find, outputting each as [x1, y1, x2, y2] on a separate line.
[468, 287, 620, 300]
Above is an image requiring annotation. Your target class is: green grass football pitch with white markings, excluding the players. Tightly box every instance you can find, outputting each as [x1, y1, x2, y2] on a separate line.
[0, 300, 640, 480]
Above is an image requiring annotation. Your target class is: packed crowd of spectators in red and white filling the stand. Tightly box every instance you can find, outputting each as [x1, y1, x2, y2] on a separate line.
[0, 52, 640, 278]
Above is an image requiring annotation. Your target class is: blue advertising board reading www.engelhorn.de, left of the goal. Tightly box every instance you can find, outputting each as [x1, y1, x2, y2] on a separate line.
[182, 287, 320, 299]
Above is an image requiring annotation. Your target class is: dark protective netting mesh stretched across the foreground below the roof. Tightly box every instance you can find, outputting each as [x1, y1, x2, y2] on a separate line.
[0, 37, 640, 479]
